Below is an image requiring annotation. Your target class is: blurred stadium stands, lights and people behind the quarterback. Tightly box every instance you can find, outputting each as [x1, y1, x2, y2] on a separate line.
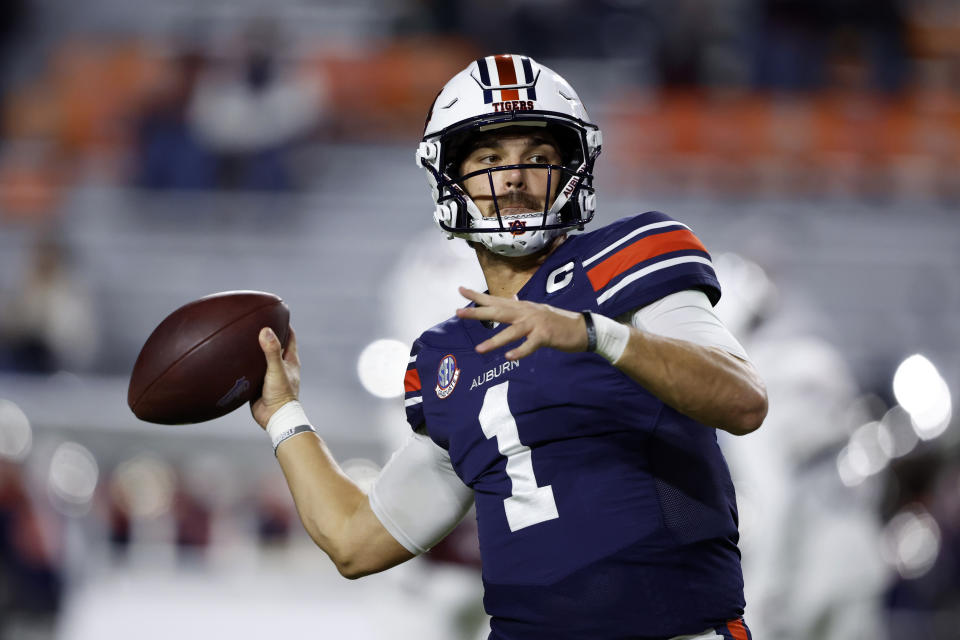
[0, 0, 960, 640]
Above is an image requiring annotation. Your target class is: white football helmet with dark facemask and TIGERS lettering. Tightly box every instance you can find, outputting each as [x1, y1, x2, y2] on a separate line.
[417, 54, 602, 256]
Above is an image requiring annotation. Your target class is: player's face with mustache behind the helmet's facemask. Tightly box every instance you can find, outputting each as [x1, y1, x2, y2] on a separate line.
[460, 132, 562, 218]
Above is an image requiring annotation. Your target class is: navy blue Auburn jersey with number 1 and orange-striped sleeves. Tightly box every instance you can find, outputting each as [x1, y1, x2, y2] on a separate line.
[405, 212, 744, 638]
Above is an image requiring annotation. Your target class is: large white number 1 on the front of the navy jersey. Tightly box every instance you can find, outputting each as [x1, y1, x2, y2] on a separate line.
[480, 381, 560, 531]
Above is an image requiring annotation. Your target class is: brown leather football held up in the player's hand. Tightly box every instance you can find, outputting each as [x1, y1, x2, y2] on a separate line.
[127, 291, 290, 424]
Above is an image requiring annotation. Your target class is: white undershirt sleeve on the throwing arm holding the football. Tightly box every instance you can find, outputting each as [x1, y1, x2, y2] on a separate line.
[369, 433, 473, 554]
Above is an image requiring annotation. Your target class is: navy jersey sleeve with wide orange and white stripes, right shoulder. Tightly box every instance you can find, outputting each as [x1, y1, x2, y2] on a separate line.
[583, 211, 720, 317]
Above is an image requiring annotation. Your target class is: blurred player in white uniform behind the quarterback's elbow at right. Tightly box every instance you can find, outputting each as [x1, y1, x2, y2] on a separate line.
[716, 256, 888, 640]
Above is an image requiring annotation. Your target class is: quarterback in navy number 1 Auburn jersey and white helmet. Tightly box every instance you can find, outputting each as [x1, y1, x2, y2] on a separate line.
[252, 55, 767, 640]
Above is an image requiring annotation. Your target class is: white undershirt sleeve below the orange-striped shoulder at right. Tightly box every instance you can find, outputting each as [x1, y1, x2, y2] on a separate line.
[617, 289, 750, 361]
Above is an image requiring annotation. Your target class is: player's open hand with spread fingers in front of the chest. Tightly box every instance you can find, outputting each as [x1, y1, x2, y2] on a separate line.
[457, 287, 587, 360]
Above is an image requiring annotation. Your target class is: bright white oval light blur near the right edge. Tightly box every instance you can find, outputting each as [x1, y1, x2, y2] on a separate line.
[893, 354, 953, 440]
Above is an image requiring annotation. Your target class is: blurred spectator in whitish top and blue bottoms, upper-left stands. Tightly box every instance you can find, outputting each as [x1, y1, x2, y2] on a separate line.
[188, 20, 325, 190]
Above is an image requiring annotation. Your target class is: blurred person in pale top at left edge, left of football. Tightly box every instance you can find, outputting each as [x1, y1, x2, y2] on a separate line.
[0, 237, 98, 373]
